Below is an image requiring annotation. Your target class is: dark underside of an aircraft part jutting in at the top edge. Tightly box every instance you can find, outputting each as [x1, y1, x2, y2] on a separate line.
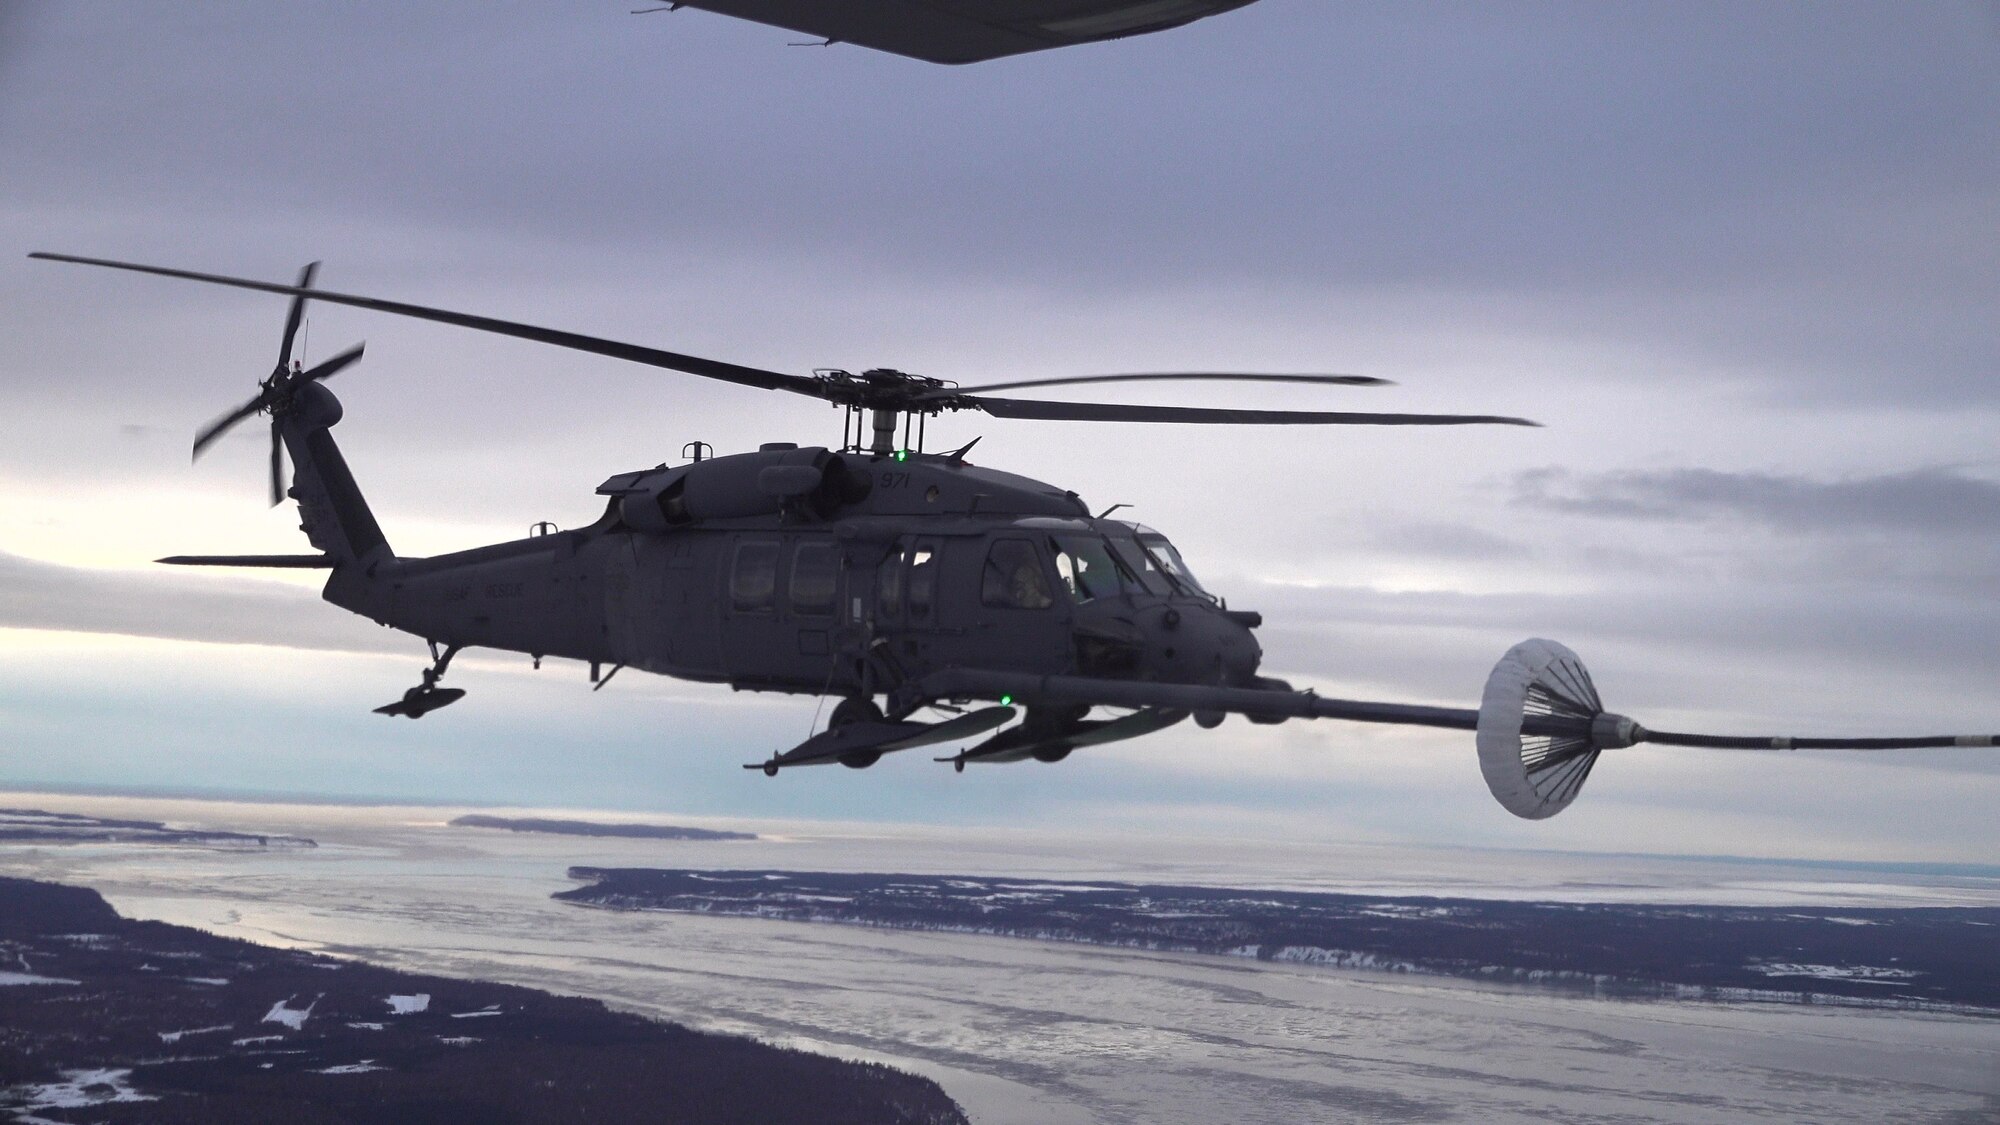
[670, 0, 1254, 64]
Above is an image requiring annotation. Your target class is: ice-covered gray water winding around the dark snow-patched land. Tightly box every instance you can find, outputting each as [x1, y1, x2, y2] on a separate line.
[0, 795, 2000, 1125]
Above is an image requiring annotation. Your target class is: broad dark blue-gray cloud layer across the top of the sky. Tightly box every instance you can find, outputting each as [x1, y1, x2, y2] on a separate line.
[0, 2, 2000, 404]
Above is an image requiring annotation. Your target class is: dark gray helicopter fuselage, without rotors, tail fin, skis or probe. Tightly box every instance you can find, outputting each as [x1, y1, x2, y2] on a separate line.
[326, 444, 1260, 697]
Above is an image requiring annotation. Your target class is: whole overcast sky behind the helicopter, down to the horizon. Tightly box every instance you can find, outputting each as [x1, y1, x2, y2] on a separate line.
[0, 0, 2000, 861]
